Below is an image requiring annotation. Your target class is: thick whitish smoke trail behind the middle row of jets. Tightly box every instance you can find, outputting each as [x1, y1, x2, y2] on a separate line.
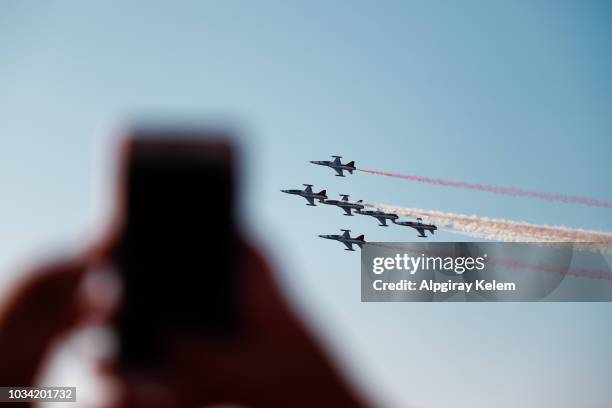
[365, 203, 612, 252]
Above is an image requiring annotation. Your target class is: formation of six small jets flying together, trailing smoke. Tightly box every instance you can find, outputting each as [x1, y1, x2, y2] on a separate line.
[281, 156, 438, 251]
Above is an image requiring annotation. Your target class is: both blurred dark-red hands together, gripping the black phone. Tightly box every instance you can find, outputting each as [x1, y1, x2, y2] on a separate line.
[0, 132, 364, 407]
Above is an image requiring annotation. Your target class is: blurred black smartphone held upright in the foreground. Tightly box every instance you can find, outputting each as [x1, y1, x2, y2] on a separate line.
[117, 131, 239, 366]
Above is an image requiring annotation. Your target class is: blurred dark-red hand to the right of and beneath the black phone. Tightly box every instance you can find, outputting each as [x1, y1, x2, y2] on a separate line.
[103, 239, 363, 407]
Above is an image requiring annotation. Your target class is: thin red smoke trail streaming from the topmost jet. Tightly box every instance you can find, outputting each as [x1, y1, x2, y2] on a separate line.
[359, 169, 612, 208]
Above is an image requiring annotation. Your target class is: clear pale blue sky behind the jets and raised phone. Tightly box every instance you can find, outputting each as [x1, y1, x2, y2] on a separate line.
[0, 0, 612, 407]
